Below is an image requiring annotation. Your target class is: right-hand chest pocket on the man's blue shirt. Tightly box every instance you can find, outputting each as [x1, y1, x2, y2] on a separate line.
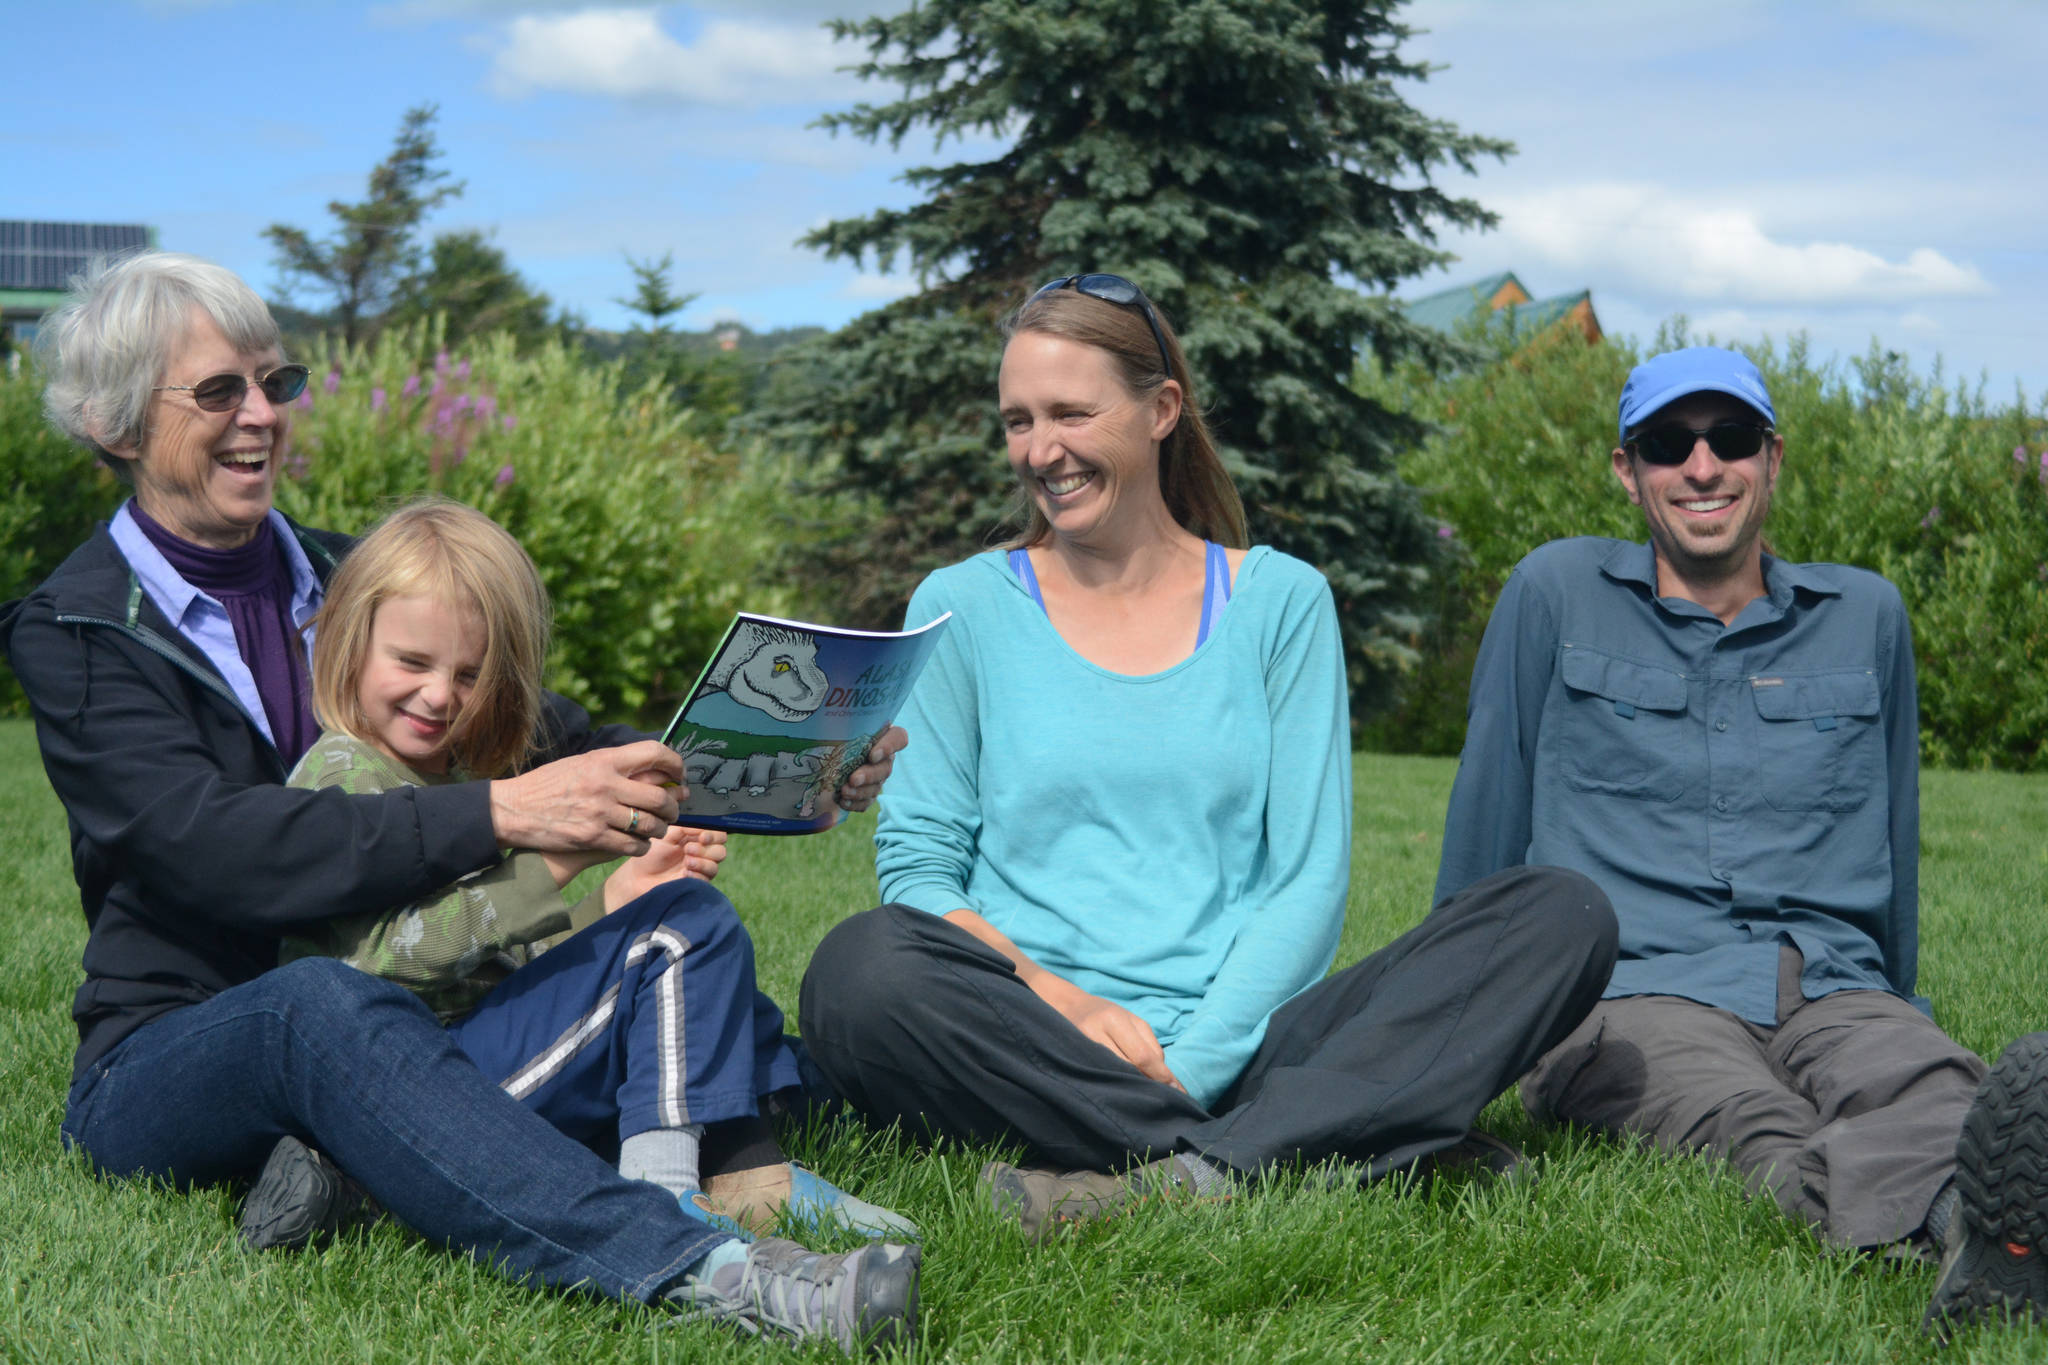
[1749, 669, 1884, 810]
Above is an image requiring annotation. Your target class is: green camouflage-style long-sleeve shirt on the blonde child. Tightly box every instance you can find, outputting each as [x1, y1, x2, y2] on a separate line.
[279, 731, 604, 1021]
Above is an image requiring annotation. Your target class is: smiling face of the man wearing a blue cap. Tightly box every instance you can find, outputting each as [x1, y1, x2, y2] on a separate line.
[1614, 393, 1784, 598]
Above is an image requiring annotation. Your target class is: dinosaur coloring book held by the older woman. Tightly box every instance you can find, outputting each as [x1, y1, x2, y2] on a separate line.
[662, 612, 952, 835]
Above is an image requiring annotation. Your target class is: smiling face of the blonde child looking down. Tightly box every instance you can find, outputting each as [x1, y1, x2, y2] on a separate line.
[356, 598, 483, 774]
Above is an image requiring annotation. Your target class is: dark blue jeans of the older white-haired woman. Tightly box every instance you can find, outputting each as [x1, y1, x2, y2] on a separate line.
[63, 958, 729, 1302]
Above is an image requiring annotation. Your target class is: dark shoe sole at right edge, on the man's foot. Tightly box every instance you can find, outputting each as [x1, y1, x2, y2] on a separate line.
[1921, 1033, 2048, 1342]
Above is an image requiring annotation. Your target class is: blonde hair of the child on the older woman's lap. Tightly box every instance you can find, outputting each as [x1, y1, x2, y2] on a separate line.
[313, 497, 551, 778]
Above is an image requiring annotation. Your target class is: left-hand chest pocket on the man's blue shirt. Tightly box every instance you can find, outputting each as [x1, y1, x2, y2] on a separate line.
[1544, 641, 1700, 800]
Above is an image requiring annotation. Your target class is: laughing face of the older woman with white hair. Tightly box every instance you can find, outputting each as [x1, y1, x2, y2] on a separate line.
[109, 309, 291, 551]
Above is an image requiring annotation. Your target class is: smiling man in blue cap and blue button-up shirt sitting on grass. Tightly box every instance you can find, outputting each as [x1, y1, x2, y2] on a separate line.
[1436, 346, 2048, 1334]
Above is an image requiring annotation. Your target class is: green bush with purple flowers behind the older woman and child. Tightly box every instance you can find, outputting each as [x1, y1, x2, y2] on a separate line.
[0, 323, 801, 722]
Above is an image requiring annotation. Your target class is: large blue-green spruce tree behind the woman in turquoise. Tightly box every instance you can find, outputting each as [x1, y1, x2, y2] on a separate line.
[764, 0, 1511, 712]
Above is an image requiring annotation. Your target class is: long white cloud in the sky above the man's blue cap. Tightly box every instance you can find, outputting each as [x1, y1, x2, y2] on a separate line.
[1489, 182, 1991, 303]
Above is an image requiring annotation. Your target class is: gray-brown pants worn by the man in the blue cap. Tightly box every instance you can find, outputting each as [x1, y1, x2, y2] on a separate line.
[1522, 945, 1985, 1246]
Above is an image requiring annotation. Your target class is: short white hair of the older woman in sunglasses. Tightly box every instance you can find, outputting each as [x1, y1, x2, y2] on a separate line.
[35, 250, 283, 477]
